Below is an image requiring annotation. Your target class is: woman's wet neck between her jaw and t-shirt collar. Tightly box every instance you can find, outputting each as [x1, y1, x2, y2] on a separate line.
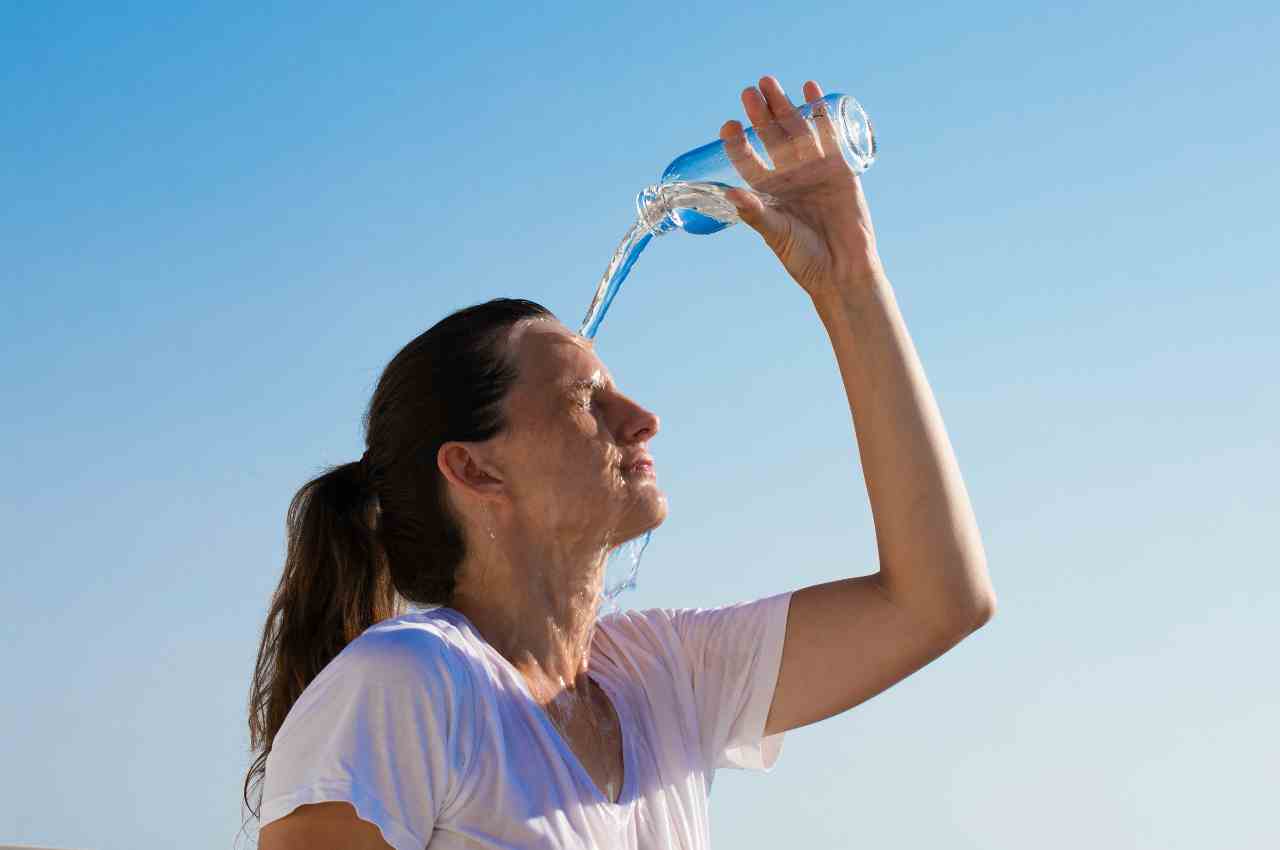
[451, 531, 608, 704]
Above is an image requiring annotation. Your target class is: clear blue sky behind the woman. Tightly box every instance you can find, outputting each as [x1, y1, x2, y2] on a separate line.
[0, 1, 1280, 850]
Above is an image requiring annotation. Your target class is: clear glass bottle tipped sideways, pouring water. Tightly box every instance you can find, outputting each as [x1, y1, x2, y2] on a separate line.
[636, 92, 876, 234]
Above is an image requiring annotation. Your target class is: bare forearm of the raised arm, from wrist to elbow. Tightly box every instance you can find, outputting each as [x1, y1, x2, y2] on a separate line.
[814, 269, 996, 627]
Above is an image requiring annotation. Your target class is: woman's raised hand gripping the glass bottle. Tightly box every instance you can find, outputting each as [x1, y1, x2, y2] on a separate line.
[719, 77, 883, 300]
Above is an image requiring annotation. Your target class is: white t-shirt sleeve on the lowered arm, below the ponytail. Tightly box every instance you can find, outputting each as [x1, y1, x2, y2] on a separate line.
[261, 621, 470, 850]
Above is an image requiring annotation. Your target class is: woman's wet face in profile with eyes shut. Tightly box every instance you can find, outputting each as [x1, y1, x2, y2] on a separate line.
[494, 320, 667, 548]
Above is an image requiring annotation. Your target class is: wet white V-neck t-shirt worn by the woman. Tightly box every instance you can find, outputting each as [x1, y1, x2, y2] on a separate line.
[261, 593, 791, 850]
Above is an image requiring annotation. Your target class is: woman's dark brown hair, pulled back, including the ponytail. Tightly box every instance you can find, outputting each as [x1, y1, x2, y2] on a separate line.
[244, 298, 554, 818]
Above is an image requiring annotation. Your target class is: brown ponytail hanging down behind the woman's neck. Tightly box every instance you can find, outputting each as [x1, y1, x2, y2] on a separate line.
[244, 461, 398, 818]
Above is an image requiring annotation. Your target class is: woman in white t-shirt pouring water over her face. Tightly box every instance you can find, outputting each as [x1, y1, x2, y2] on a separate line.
[246, 77, 995, 850]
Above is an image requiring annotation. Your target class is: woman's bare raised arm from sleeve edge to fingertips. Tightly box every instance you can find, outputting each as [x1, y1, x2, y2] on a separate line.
[721, 77, 996, 735]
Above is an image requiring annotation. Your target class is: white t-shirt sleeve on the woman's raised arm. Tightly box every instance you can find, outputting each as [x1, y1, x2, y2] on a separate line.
[667, 593, 791, 771]
